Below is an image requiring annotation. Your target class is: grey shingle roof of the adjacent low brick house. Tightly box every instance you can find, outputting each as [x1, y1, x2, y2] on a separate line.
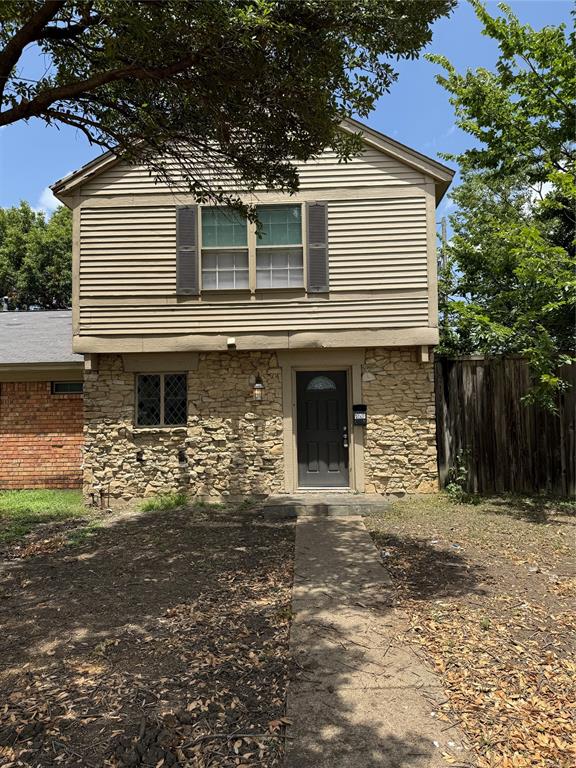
[0, 310, 83, 366]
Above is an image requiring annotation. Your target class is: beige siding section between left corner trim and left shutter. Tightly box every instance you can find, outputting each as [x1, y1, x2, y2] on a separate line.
[80, 206, 176, 299]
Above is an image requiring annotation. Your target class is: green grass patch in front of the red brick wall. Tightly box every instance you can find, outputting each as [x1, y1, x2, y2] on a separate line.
[0, 490, 86, 543]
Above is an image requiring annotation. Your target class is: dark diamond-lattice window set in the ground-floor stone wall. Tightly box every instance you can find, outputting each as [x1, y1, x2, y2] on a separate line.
[136, 373, 188, 427]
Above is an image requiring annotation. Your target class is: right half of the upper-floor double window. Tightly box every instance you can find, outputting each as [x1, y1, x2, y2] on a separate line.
[256, 205, 304, 288]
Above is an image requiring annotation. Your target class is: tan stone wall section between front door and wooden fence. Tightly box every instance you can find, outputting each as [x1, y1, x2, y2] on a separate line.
[362, 348, 438, 494]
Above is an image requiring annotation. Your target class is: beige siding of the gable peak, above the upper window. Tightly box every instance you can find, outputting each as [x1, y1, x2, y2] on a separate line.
[82, 146, 425, 197]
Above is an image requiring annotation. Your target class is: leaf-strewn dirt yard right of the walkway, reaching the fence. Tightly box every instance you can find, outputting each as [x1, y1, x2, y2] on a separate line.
[366, 495, 576, 768]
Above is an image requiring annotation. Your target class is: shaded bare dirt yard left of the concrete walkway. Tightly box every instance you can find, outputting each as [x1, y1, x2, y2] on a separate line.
[0, 500, 293, 768]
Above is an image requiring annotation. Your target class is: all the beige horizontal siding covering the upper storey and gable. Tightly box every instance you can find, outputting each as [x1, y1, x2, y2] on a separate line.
[75, 146, 430, 345]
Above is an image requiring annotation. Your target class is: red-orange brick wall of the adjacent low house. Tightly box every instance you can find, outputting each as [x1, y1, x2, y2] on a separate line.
[0, 381, 83, 490]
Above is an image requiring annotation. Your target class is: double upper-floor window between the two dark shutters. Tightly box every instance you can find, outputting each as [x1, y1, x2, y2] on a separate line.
[201, 205, 304, 290]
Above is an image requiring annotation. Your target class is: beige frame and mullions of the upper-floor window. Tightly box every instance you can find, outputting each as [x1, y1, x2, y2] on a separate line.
[198, 201, 306, 295]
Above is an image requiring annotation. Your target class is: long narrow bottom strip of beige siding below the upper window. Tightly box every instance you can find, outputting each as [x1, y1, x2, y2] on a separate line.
[80, 298, 428, 336]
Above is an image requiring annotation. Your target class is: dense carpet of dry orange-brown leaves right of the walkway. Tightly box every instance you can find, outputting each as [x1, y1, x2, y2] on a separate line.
[413, 597, 576, 768]
